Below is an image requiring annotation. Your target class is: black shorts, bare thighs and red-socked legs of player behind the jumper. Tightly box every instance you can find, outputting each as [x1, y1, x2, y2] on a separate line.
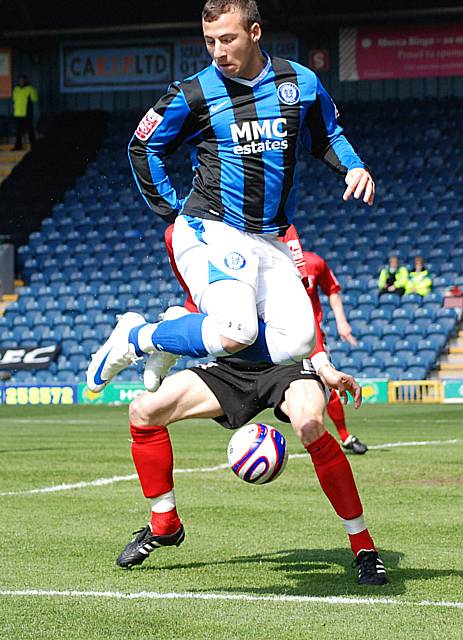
[117, 344, 387, 585]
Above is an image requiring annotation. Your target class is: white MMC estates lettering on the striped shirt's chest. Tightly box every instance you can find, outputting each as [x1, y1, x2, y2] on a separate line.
[230, 118, 288, 156]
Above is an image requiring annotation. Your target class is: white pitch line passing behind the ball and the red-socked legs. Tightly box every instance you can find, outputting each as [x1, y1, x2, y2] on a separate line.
[0, 439, 463, 497]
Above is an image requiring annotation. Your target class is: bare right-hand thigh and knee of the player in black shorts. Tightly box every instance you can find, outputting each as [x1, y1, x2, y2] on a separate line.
[281, 379, 326, 444]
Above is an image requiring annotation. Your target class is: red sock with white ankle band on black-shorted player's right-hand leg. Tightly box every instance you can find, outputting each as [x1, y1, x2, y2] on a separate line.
[306, 431, 375, 555]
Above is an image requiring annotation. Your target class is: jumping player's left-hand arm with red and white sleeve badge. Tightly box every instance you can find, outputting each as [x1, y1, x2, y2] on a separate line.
[128, 83, 197, 222]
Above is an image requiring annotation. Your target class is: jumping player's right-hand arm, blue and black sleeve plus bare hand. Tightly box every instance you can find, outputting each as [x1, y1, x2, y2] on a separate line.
[304, 78, 375, 205]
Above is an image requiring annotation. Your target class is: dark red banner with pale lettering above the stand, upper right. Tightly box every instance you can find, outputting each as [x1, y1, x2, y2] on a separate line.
[339, 24, 463, 80]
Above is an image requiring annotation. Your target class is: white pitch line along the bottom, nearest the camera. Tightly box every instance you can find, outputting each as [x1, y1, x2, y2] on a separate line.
[0, 589, 463, 609]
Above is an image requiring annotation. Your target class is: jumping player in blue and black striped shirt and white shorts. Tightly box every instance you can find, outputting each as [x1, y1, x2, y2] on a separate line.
[87, 0, 374, 392]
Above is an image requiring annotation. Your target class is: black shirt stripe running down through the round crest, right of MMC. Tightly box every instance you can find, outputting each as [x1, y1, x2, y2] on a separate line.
[272, 58, 301, 229]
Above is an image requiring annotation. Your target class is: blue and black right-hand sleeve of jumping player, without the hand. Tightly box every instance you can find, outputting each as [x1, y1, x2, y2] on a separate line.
[302, 78, 365, 175]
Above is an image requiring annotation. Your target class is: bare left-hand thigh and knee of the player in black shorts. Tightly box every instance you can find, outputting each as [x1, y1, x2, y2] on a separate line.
[130, 371, 223, 425]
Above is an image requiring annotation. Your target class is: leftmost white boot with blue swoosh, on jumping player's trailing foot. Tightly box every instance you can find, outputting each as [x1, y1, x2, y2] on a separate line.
[87, 311, 146, 393]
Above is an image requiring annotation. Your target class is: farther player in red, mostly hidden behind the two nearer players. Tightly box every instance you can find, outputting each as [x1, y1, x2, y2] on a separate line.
[282, 225, 368, 455]
